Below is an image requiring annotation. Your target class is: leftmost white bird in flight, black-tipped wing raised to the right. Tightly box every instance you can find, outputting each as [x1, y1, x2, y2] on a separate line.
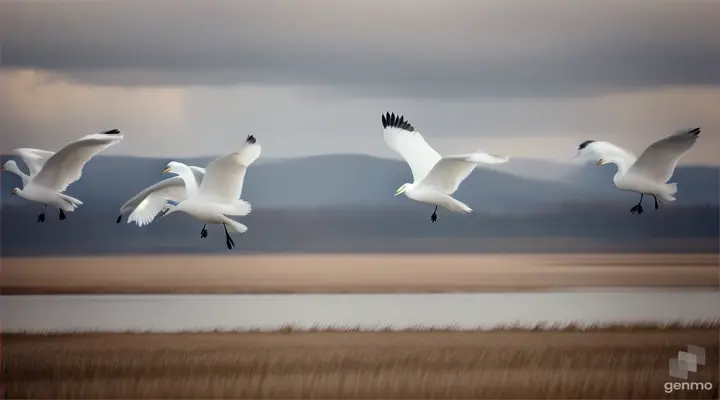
[12, 129, 123, 222]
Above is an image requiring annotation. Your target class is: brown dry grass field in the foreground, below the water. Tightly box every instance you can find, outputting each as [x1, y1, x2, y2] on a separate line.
[2, 323, 720, 399]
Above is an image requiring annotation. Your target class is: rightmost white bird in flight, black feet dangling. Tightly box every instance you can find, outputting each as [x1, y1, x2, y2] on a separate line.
[578, 128, 700, 214]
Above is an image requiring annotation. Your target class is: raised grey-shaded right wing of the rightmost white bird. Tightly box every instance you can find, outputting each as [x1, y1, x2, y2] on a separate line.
[628, 128, 700, 183]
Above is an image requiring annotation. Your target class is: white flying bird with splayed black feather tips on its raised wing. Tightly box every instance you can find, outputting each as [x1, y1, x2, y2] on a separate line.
[382, 113, 509, 222]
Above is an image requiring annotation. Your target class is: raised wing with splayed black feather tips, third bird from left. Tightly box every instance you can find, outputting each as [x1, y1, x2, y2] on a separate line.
[382, 113, 442, 183]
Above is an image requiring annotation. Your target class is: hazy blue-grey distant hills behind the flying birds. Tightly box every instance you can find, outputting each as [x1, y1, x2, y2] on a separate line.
[0, 155, 719, 256]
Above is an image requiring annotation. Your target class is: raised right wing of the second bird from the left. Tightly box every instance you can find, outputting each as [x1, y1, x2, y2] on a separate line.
[198, 135, 261, 202]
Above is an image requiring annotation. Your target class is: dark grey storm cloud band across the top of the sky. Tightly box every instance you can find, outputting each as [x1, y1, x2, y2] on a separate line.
[0, 0, 720, 97]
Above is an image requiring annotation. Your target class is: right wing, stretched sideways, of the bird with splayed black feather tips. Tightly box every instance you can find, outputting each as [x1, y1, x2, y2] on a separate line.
[420, 152, 509, 195]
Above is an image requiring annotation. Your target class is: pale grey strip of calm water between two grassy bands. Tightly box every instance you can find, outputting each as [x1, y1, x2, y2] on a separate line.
[0, 288, 720, 332]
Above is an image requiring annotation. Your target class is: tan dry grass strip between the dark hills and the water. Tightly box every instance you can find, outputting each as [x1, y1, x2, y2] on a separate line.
[0, 254, 719, 294]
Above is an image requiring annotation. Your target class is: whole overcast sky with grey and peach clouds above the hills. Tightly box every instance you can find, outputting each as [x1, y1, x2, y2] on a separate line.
[0, 0, 720, 163]
